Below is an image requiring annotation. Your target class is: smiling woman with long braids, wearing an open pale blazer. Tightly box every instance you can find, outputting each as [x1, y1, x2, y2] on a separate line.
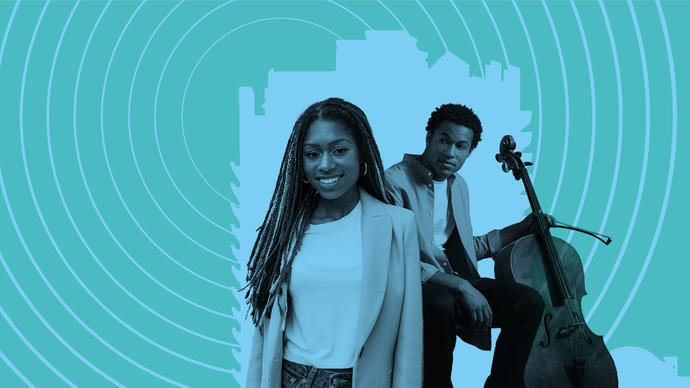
[247, 98, 422, 388]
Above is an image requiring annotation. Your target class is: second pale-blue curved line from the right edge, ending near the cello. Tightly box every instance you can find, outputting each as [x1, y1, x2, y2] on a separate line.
[587, 2, 651, 322]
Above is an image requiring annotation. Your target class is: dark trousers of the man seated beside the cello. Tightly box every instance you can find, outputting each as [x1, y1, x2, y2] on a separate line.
[422, 278, 544, 388]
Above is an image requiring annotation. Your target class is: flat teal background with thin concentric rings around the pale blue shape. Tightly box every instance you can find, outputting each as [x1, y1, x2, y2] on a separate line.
[0, 1, 690, 387]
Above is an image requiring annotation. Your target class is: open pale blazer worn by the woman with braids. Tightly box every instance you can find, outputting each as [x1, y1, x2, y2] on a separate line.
[246, 188, 423, 388]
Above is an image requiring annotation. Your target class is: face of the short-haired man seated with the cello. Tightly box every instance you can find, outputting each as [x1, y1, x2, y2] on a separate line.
[422, 120, 474, 181]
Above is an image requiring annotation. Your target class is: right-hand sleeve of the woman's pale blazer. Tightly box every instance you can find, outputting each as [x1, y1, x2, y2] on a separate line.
[392, 213, 424, 388]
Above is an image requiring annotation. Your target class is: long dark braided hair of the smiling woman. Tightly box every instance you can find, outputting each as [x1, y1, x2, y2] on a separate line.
[245, 98, 393, 326]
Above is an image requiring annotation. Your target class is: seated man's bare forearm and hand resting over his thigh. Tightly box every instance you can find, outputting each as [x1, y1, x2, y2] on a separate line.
[429, 271, 493, 330]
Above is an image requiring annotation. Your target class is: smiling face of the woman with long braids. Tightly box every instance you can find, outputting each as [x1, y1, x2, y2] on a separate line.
[303, 119, 360, 199]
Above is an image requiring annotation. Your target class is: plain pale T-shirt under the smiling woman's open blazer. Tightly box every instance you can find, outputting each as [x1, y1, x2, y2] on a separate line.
[283, 203, 362, 368]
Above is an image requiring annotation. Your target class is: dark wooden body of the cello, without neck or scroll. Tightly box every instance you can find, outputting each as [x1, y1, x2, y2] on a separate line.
[495, 235, 618, 388]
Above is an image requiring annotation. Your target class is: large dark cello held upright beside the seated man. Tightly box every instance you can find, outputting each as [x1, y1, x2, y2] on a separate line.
[494, 135, 618, 388]
